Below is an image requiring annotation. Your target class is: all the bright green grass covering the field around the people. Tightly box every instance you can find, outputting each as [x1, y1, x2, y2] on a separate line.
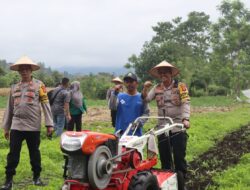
[0, 97, 250, 190]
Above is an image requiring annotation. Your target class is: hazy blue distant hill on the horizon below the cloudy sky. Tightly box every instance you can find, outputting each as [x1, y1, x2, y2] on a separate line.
[54, 66, 128, 75]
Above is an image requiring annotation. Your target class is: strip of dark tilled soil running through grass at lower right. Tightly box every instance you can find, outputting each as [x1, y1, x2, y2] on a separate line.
[187, 126, 250, 190]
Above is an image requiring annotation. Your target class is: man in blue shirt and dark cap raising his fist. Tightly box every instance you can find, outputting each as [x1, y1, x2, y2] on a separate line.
[110, 72, 149, 136]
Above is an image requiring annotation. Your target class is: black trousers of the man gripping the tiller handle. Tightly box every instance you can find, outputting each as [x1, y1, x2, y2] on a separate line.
[158, 132, 187, 175]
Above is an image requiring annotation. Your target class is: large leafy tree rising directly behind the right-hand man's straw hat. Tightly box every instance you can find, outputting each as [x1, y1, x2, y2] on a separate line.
[125, 12, 211, 83]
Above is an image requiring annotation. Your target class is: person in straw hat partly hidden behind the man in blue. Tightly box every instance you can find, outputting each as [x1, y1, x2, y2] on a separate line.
[106, 77, 123, 127]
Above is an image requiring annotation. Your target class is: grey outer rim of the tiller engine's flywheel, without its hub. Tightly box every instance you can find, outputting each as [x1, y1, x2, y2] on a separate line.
[88, 145, 112, 189]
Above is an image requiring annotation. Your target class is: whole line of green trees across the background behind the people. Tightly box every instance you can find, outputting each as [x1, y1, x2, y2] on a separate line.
[0, 0, 250, 99]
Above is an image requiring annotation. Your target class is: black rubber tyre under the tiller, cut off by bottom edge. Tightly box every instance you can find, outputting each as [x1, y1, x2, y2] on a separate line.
[128, 171, 159, 190]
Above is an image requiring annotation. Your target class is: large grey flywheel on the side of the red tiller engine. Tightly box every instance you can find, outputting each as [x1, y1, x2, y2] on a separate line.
[88, 146, 113, 189]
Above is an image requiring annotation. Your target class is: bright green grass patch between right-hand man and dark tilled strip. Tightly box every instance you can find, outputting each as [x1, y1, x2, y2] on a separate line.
[187, 105, 250, 160]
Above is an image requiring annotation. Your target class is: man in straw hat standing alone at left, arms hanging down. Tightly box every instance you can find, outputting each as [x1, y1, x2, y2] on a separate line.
[1, 56, 53, 190]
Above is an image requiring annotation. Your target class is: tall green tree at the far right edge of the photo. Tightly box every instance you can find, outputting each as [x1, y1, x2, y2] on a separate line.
[211, 0, 250, 96]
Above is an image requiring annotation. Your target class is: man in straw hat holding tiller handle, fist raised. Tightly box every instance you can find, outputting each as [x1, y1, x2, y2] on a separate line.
[142, 61, 190, 189]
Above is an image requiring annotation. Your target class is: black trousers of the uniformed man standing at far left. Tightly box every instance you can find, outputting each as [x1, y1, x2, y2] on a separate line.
[5, 130, 42, 179]
